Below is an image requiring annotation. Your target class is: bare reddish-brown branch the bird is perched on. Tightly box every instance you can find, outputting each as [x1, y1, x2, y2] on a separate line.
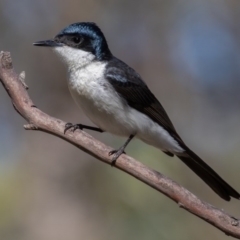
[0, 52, 240, 239]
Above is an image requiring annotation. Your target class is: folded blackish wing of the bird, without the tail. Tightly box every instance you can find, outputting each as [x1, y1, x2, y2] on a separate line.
[105, 58, 185, 146]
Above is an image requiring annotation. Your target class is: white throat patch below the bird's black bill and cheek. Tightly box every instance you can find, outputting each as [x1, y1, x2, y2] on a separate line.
[53, 46, 95, 71]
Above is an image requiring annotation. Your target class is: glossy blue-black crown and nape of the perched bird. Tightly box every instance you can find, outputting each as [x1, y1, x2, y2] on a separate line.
[56, 22, 111, 60]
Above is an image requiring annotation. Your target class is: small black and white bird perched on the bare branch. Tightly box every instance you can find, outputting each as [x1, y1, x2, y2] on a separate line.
[34, 22, 240, 201]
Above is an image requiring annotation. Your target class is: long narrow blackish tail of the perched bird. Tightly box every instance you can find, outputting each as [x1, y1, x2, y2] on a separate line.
[178, 148, 240, 201]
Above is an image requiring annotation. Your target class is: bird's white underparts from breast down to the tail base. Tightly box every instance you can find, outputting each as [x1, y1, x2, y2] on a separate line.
[66, 63, 183, 153]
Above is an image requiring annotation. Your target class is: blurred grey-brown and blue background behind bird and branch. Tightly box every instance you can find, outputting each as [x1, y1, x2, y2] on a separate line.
[0, 0, 240, 240]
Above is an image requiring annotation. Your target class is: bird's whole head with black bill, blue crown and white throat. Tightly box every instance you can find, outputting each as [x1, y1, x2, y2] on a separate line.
[33, 22, 112, 68]
